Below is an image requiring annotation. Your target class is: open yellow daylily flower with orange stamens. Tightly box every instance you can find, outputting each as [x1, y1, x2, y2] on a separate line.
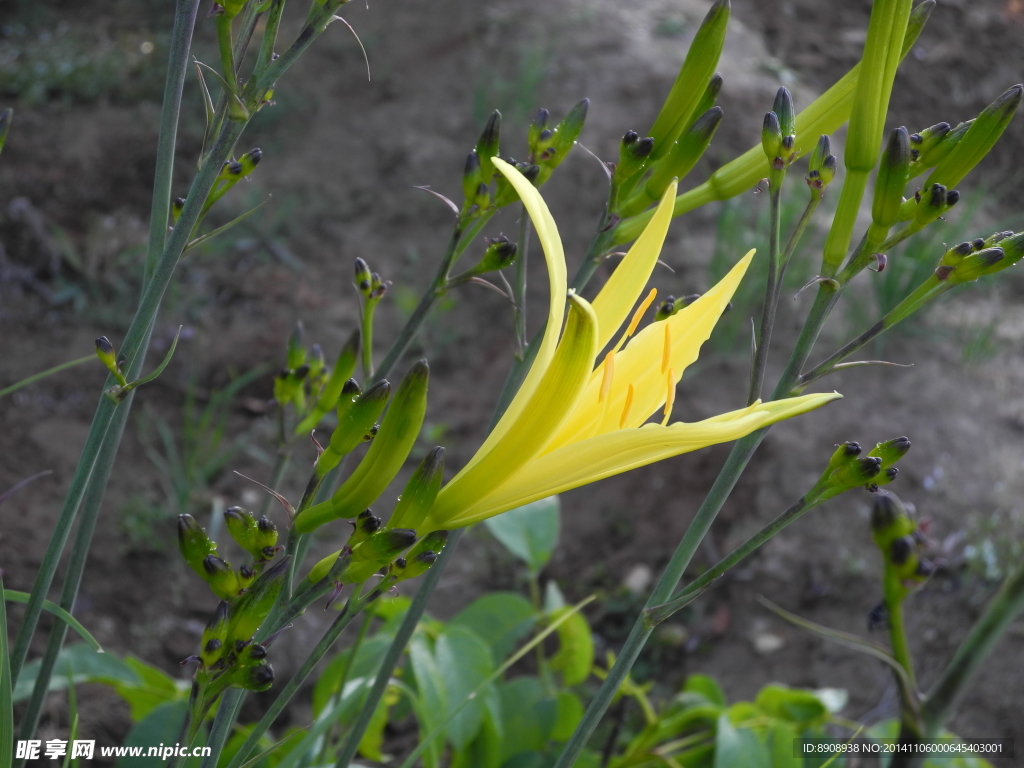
[421, 158, 842, 532]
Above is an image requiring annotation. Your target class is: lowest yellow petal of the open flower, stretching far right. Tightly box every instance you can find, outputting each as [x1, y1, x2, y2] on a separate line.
[427, 392, 842, 528]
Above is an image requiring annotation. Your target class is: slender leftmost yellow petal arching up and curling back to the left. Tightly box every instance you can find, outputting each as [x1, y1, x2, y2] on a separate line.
[456, 158, 568, 479]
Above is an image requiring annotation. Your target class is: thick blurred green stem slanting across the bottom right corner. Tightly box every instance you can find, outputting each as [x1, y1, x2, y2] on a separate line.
[923, 563, 1024, 736]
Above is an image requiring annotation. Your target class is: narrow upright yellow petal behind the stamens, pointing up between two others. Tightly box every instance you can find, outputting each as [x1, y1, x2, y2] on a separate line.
[594, 180, 677, 349]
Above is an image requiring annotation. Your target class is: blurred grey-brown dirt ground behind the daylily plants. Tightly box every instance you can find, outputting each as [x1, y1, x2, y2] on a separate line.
[0, 0, 1024, 765]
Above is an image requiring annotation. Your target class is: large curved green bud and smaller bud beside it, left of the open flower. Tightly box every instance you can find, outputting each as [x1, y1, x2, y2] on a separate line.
[294, 360, 432, 534]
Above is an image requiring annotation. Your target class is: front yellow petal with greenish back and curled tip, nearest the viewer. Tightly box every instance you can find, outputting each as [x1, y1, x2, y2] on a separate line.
[431, 294, 597, 519]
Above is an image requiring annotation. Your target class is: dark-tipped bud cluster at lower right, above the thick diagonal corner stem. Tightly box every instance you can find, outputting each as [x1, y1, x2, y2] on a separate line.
[871, 490, 935, 601]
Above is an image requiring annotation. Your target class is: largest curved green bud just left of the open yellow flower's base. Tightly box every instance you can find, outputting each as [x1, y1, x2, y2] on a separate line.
[295, 360, 430, 534]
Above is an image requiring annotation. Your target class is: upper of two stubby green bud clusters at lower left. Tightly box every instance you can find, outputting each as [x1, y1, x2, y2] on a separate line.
[178, 507, 281, 602]
